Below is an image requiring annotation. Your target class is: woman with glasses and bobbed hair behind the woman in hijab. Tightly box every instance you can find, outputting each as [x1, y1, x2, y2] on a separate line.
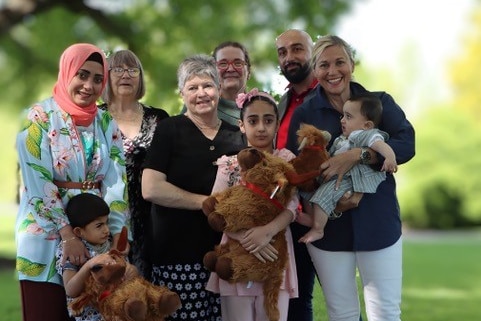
[99, 50, 169, 278]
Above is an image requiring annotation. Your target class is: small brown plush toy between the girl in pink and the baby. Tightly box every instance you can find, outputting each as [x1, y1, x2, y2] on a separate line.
[290, 124, 331, 192]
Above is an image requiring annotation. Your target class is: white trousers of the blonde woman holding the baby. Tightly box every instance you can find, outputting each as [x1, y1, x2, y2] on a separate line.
[307, 238, 402, 321]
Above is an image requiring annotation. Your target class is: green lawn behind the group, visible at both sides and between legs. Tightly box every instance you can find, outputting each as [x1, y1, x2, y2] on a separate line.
[0, 211, 481, 321]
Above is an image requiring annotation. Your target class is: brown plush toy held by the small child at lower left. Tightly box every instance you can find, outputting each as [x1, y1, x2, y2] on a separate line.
[69, 228, 180, 321]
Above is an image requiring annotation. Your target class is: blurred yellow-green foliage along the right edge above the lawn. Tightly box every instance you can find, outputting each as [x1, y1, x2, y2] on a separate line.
[401, 4, 481, 228]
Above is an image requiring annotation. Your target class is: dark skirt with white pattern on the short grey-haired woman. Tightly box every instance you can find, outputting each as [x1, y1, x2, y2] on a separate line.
[152, 263, 222, 321]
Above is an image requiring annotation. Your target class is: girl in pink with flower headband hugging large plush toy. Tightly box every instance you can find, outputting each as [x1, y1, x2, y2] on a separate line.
[207, 88, 298, 321]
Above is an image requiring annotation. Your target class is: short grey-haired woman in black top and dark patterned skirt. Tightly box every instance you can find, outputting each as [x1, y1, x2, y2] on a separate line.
[142, 55, 245, 321]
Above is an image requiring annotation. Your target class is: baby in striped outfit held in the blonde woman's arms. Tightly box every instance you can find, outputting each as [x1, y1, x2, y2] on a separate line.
[299, 94, 397, 243]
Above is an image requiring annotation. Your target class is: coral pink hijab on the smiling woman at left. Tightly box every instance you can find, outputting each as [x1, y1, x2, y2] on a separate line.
[53, 43, 108, 126]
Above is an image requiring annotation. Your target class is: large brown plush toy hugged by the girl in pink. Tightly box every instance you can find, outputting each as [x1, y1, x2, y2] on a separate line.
[203, 148, 318, 321]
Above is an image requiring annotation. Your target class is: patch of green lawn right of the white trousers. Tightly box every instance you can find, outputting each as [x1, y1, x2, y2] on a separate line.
[402, 240, 481, 321]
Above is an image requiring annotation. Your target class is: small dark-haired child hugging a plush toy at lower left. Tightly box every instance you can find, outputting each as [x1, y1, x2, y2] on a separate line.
[56, 193, 138, 321]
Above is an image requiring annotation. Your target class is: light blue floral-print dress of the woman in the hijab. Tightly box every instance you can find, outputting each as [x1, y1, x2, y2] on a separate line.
[15, 98, 129, 285]
